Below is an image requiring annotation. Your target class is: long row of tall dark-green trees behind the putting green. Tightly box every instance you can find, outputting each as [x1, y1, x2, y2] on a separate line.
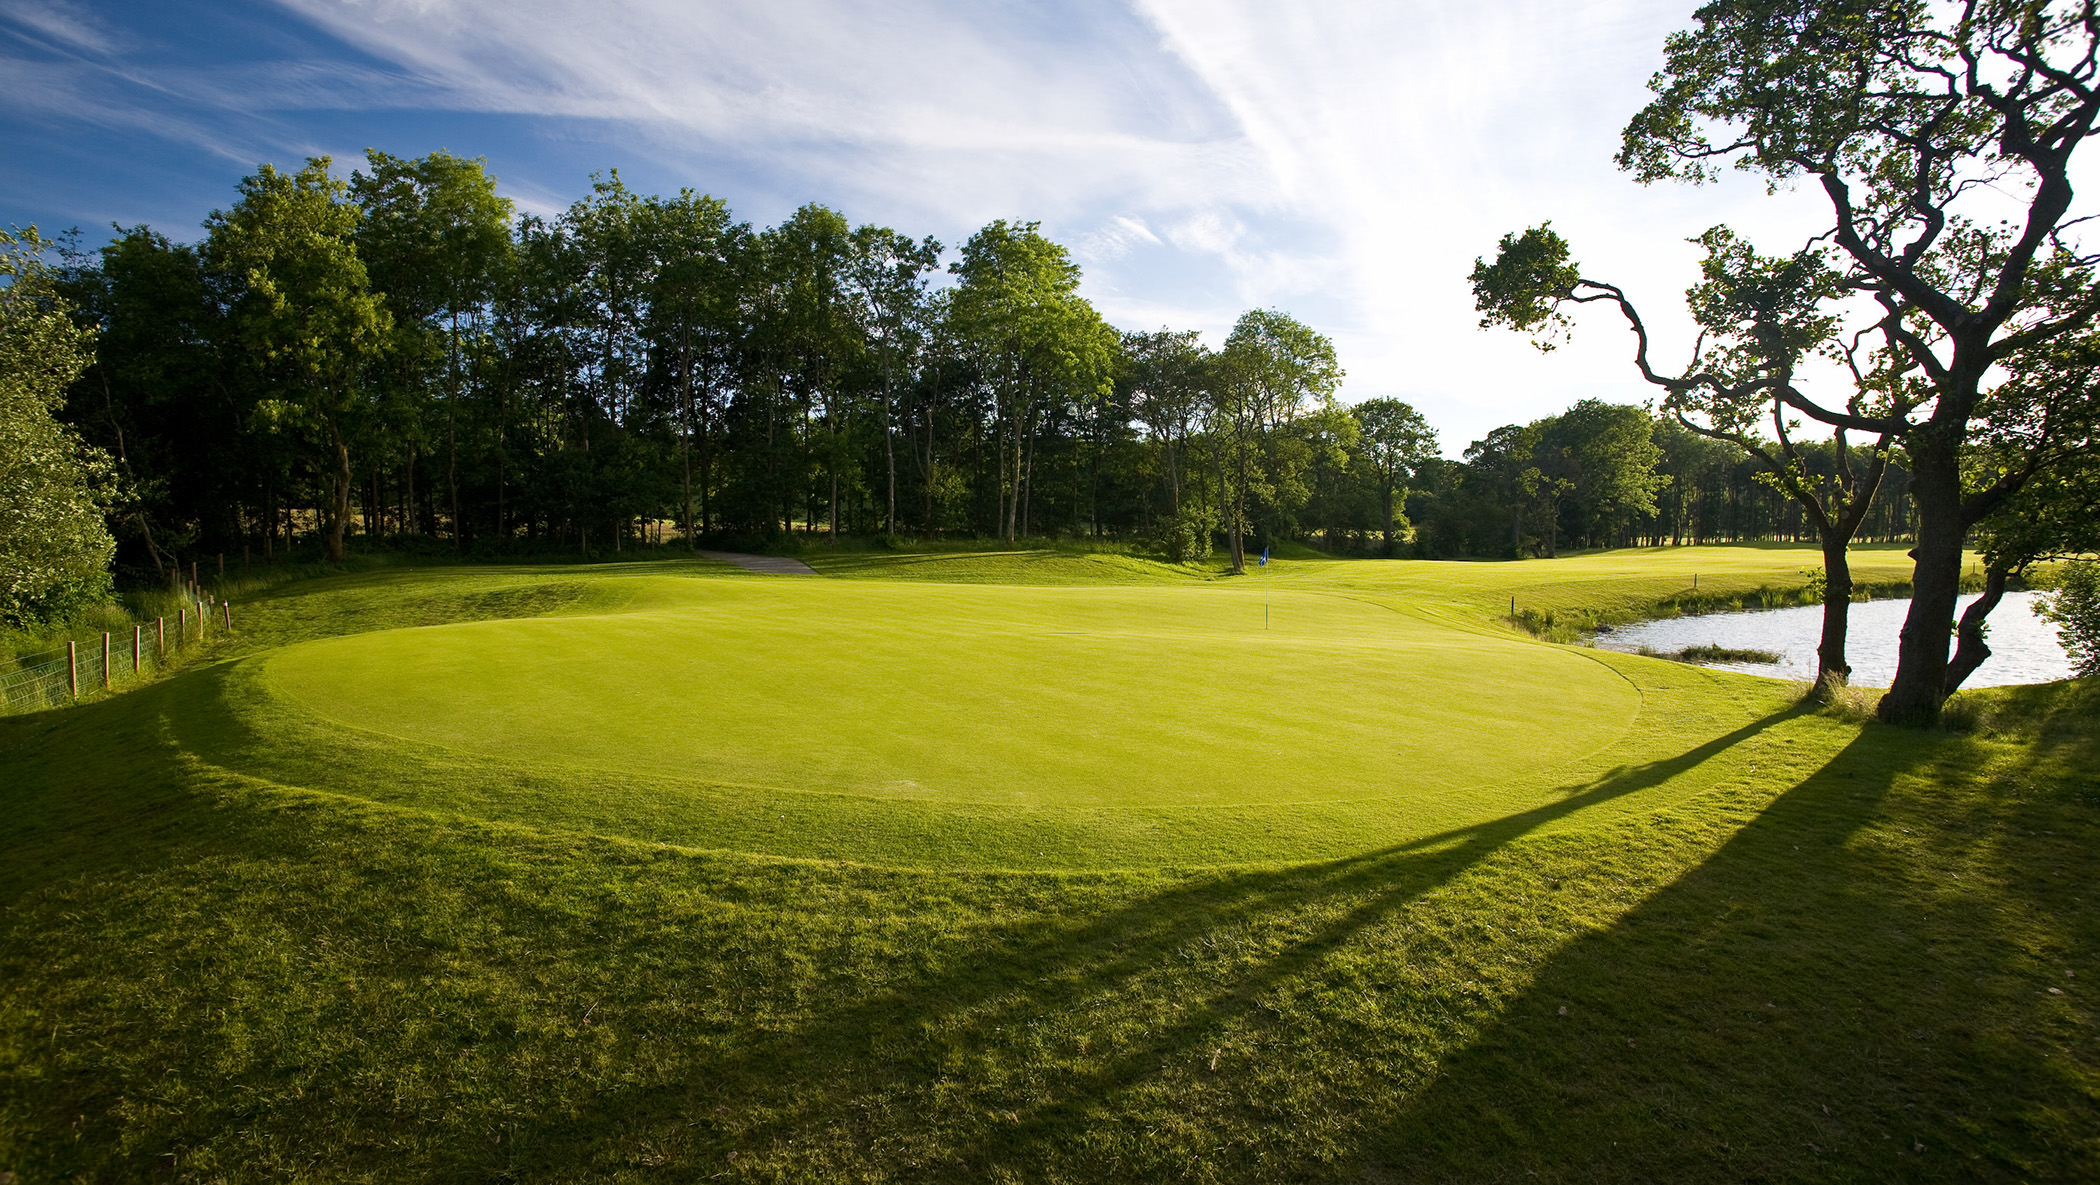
[59, 151, 1909, 588]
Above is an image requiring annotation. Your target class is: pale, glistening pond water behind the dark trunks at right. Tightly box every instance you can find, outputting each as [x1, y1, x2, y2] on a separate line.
[1596, 593, 2071, 687]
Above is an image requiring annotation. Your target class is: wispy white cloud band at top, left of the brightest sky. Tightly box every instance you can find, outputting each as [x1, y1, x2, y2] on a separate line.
[266, 0, 1252, 221]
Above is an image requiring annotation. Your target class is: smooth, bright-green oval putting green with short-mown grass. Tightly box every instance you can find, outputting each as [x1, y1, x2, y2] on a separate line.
[249, 578, 1688, 864]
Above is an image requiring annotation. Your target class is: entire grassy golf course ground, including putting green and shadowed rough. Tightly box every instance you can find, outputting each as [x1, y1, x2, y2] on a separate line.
[0, 544, 2100, 1183]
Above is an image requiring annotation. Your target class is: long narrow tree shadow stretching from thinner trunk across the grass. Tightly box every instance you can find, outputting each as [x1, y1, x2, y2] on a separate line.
[480, 706, 1804, 1179]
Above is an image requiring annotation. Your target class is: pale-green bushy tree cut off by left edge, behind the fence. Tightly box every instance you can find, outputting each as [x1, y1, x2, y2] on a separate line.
[0, 227, 116, 626]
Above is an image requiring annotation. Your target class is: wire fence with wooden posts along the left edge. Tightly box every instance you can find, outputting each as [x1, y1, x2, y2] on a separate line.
[0, 599, 233, 714]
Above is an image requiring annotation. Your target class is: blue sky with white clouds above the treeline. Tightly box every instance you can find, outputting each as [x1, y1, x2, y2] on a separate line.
[0, 0, 1881, 456]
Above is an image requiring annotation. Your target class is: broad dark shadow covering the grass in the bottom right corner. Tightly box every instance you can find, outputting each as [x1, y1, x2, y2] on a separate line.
[1361, 687, 2100, 1181]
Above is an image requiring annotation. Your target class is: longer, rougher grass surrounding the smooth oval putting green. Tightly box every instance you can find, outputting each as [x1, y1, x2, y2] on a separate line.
[0, 553, 2100, 1181]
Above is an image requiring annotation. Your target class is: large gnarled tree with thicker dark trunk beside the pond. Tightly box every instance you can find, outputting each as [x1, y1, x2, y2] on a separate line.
[1619, 0, 2100, 723]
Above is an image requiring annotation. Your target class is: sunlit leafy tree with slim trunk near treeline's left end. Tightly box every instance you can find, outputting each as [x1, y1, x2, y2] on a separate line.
[206, 155, 391, 561]
